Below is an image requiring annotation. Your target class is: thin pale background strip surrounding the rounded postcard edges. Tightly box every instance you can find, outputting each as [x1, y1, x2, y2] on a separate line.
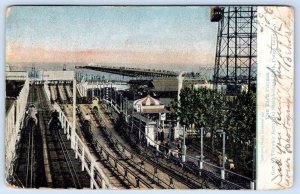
[0, 0, 300, 194]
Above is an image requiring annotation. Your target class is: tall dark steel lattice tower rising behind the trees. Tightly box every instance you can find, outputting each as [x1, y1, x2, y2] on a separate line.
[211, 6, 257, 92]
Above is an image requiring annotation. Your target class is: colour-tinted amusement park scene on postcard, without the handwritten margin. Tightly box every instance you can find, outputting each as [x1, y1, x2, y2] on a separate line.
[5, 6, 292, 190]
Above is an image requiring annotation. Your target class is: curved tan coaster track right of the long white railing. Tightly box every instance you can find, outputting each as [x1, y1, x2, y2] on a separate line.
[80, 105, 169, 189]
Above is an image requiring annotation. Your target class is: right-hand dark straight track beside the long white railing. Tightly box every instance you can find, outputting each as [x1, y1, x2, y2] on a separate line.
[37, 87, 89, 189]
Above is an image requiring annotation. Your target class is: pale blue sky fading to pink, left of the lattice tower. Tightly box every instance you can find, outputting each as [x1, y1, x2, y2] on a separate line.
[6, 6, 217, 70]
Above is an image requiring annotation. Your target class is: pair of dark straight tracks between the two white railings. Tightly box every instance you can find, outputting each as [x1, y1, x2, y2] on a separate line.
[14, 85, 90, 189]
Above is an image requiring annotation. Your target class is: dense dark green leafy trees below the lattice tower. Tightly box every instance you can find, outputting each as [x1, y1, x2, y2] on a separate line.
[172, 87, 256, 176]
